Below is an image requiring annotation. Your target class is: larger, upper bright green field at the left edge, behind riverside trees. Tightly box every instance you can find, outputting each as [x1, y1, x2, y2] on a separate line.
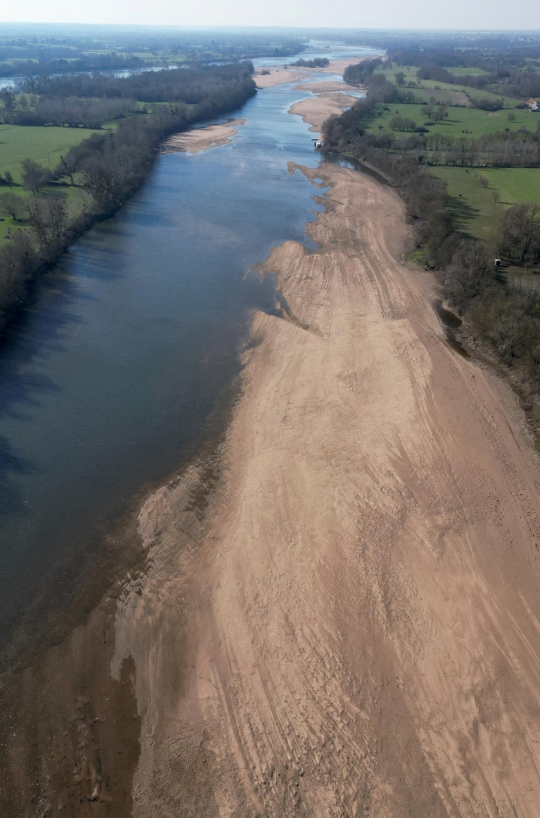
[0, 125, 103, 182]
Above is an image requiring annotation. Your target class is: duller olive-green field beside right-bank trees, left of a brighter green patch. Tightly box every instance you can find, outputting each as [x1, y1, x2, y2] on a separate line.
[430, 167, 504, 241]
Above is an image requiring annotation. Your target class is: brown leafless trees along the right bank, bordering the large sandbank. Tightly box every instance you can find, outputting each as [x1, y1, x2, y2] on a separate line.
[323, 60, 540, 391]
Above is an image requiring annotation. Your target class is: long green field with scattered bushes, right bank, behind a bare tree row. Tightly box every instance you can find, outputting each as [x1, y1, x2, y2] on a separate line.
[369, 103, 537, 137]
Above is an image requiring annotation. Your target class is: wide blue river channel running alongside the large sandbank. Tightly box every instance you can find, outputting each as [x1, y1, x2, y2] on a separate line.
[0, 47, 376, 668]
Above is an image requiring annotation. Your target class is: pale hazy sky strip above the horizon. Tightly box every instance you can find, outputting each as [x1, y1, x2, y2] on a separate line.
[0, 0, 540, 30]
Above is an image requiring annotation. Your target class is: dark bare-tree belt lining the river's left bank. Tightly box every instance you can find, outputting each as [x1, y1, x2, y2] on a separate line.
[0, 59, 256, 334]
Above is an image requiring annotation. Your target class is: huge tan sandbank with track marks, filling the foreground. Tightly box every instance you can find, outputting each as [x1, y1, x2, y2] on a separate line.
[115, 139, 540, 818]
